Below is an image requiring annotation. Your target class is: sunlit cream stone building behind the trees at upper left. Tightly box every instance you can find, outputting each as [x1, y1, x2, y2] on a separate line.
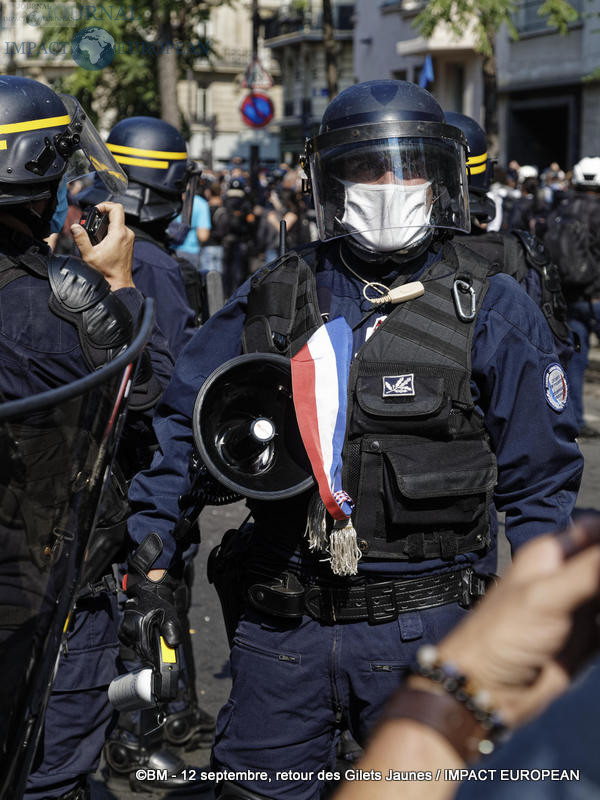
[0, 0, 282, 168]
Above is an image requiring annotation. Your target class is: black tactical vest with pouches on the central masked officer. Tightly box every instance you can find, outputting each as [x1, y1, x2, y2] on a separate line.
[244, 243, 497, 561]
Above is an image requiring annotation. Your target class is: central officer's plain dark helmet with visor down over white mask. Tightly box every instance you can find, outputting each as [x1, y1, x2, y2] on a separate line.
[305, 80, 470, 260]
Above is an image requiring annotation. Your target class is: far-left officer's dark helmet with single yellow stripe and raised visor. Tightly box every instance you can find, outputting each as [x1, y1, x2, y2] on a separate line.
[0, 75, 127, 235]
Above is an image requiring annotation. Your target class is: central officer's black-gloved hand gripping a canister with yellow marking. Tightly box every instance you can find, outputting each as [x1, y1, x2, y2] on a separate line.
[119, 572, 182, 664]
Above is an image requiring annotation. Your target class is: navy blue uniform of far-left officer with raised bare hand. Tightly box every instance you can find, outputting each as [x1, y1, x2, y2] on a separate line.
[0, 245, 172, 799]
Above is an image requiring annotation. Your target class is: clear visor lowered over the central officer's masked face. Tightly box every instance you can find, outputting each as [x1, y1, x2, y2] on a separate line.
[309, 136, 470, 249]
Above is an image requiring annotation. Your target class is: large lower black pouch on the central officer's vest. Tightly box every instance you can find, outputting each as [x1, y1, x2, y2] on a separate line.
[355, 436, 497, 558]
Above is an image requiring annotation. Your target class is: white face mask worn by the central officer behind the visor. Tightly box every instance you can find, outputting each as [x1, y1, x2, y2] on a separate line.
[338, 179, 431, 253]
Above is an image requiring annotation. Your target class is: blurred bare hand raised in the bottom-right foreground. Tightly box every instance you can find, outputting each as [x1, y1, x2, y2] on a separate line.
[438, 517, 600, 726]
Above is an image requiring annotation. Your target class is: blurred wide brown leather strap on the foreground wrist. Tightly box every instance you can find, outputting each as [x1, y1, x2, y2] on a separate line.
[380, 687, 489, 763]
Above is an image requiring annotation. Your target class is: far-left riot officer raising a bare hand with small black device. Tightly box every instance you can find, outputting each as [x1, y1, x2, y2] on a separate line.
[0, 76, 172, 798]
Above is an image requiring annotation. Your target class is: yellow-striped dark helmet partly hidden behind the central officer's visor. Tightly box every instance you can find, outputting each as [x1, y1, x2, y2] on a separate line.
[446, 111, 496, 222]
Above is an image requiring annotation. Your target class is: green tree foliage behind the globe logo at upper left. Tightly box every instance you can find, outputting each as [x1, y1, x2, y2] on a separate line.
[37, 0, 218, 124]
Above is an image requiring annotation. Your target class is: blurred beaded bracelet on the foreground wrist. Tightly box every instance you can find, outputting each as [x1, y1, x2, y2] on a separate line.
[413, 644, 506, 755]
